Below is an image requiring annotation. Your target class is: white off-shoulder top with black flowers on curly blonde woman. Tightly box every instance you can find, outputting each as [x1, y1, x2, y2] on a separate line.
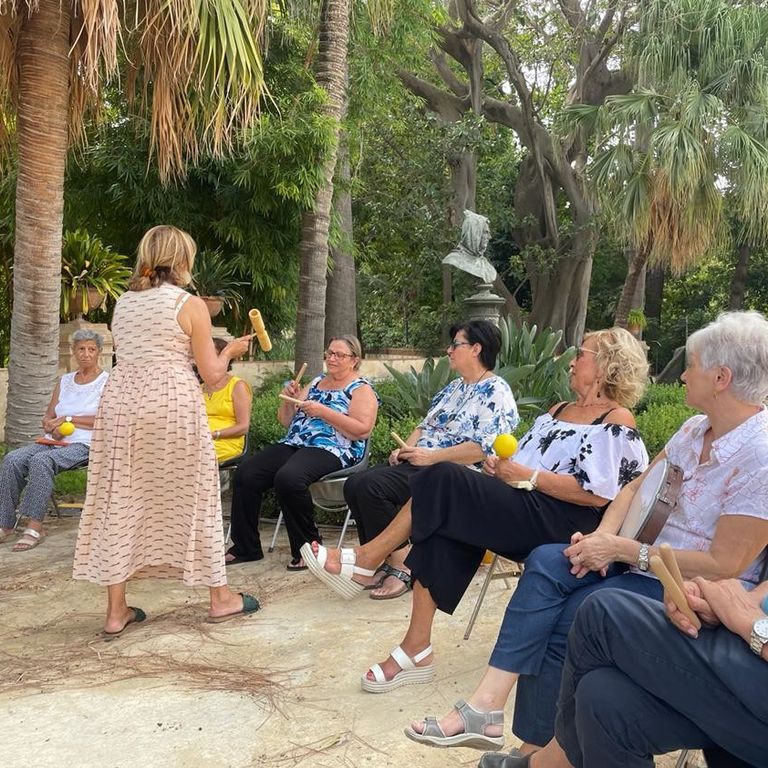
[512, 413, 648, 499]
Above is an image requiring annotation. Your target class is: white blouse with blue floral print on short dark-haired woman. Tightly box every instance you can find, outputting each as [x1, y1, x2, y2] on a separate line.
[416, 376, 520, 467]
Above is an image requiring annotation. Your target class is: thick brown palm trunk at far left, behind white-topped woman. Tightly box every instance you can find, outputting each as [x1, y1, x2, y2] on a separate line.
[5, 0, 70, 446]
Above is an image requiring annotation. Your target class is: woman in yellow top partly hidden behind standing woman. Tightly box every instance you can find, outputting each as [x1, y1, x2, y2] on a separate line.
[202, 338, 253, 464]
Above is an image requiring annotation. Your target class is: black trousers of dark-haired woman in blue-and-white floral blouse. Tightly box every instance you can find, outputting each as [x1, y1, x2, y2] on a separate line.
[344, 461, 424, 549]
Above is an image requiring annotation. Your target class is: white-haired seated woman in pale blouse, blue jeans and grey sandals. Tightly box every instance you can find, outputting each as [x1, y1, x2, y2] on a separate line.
[406, 312, 768, 748]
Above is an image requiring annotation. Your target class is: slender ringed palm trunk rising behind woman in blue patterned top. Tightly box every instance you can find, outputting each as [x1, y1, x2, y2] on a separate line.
[296, 0, 350, 376]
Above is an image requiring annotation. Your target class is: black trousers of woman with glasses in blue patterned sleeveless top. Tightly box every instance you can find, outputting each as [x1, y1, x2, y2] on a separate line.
[229, 443, 341, 560]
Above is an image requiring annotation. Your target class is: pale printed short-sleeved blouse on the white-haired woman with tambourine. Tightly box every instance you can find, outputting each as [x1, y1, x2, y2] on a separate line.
[656, 408, 768, 583]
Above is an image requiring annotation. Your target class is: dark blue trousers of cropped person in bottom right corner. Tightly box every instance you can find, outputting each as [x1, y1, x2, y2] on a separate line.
[555, 590, 768, 768]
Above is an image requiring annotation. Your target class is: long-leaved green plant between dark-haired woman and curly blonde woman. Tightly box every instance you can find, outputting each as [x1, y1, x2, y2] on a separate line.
[496, 318, 576, 416]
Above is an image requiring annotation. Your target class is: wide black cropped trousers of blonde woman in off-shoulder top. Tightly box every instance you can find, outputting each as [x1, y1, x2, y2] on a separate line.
[405, 463, 602, 613]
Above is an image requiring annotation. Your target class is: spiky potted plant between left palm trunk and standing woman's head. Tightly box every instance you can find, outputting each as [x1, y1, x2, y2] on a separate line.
[61, 229, 131, 320]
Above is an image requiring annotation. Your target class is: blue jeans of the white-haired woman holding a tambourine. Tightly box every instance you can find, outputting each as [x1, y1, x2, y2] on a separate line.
[489, 544, 663, 746]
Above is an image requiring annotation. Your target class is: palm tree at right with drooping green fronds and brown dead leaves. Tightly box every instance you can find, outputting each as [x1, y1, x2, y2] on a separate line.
[570, 0, 768, 325]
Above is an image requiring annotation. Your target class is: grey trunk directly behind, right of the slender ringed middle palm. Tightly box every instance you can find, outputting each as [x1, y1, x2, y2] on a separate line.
[325, 132, 357, 342]
